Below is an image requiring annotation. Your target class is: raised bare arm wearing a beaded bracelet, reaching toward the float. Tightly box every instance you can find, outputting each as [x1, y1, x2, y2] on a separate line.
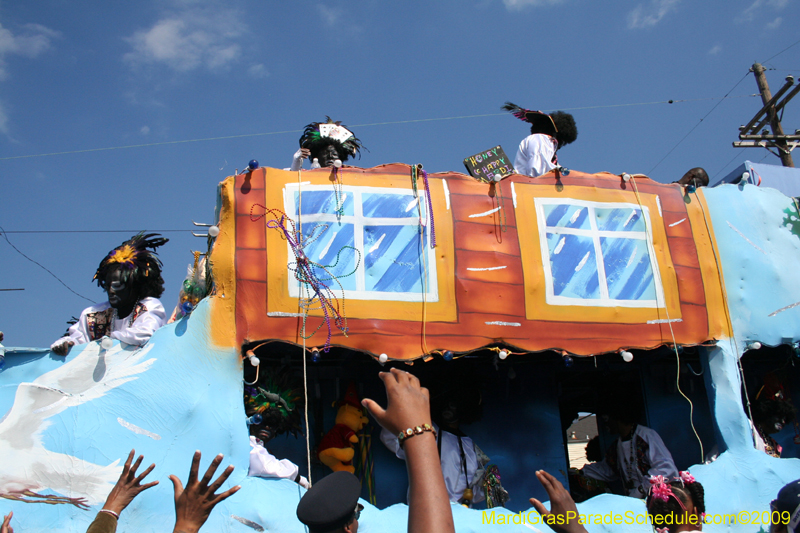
[362, 368, 455, 533]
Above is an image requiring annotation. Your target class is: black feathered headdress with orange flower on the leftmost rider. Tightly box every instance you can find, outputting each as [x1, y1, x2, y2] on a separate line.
[93, 232, 169, 298]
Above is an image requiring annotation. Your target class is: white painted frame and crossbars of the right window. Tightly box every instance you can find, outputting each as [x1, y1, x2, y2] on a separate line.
[534, 198, 666, 309]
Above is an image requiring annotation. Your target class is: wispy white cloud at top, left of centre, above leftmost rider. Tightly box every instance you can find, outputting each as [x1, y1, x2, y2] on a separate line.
[123, 4, 243, 72]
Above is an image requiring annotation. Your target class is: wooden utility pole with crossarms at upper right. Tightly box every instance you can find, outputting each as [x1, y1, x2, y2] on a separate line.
[733, 63, 800, 167]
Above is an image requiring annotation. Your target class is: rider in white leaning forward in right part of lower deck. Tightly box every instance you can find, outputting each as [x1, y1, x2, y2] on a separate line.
[581, 399, 678, 499]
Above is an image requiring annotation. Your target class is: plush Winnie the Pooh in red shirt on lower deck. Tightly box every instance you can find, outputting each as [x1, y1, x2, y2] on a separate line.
[317, 383, 369, 474]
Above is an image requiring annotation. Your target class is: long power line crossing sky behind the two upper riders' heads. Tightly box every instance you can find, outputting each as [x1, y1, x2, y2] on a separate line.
[0, 91, 758, 161]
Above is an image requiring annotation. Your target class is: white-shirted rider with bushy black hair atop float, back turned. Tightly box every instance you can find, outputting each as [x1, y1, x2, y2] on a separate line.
[503, 102, 578, 178]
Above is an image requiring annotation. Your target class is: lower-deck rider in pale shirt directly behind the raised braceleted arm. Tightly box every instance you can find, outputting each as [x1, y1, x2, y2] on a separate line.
[381, 385, 496, 507]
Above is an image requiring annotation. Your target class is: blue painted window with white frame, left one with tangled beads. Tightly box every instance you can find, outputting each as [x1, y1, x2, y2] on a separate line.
[285, 184, 438, 302]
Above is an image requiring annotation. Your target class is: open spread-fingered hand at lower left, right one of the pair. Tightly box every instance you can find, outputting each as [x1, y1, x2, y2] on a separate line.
[169, 451, 242, 533]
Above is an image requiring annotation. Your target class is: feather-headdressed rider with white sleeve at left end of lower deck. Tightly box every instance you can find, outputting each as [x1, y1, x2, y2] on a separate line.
[244, 366, 308, 488]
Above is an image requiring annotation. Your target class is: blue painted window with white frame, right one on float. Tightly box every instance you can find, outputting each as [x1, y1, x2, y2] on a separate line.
[535, 198, 664, 307]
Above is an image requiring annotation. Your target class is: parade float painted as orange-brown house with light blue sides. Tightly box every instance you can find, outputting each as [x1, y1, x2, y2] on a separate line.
[0, 160, 800, 533]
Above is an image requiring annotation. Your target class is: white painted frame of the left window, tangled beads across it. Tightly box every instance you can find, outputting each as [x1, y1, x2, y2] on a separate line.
[283, 182, 439, 302]
